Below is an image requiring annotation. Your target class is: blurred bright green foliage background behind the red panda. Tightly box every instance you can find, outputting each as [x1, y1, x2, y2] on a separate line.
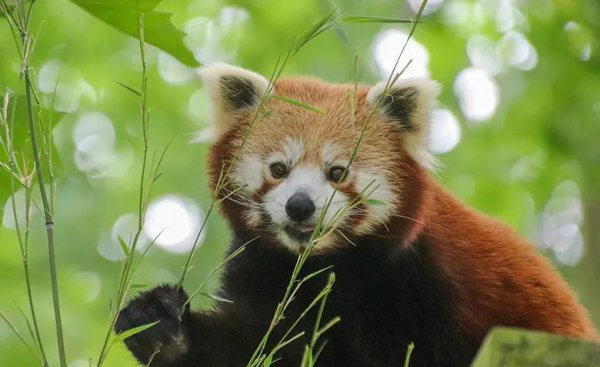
[0, 0, 600, 367]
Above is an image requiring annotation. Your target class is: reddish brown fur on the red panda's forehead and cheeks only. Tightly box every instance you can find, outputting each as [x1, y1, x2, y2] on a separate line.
[209, 78, 418, 234]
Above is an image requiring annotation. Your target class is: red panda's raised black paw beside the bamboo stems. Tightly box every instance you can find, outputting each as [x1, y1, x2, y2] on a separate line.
[115, 285, 190, 365]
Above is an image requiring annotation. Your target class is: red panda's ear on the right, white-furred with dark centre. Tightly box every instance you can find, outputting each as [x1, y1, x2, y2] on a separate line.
[366, 78, 440, 168]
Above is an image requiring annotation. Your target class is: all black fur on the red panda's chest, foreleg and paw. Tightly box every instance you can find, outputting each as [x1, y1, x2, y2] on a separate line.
[113, 238, 477, 367]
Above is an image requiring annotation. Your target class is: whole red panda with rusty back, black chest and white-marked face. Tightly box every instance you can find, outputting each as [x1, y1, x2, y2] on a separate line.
[116, 64, 598, 367]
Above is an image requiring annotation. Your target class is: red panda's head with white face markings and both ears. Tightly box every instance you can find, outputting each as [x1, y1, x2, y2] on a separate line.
[200, 64, 438, 253]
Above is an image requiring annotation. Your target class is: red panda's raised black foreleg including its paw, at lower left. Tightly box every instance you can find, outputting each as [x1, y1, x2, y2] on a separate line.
[115, 285, 251, 367]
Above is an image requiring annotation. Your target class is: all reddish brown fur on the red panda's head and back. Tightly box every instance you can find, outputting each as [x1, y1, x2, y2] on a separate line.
[210, 79, 598, 342]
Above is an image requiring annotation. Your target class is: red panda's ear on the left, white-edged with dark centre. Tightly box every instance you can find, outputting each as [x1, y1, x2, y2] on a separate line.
[198, 63, 269, 135]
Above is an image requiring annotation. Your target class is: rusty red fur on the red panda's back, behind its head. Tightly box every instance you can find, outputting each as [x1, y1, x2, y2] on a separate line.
[423, 183, 598, 340]
